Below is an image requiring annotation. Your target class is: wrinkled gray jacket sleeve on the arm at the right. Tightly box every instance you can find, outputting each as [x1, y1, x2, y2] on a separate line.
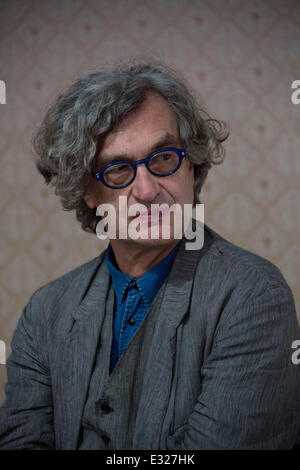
[168, 284, 300, 450]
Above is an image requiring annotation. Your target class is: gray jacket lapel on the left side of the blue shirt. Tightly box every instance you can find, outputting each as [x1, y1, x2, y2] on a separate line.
[57, 258, 113, 449]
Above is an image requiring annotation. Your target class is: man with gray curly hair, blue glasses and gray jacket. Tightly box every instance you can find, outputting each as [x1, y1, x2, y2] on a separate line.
[0, 63, 299, 450]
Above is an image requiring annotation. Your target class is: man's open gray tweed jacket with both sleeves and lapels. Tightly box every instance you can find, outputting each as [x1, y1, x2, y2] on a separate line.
[0, 226, 300, 450]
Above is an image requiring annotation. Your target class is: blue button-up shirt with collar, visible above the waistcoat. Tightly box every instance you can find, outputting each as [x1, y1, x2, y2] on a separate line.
[105, 242, 180, 372]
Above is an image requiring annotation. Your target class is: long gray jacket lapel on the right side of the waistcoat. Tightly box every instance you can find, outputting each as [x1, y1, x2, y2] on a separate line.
[134, 228, 210, 449]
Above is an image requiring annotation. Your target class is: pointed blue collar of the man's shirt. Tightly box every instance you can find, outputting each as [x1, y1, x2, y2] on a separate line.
[105, 240, 181, 307]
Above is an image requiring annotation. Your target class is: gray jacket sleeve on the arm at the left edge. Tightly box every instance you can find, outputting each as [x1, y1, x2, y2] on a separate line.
[0, 299, 54, 450]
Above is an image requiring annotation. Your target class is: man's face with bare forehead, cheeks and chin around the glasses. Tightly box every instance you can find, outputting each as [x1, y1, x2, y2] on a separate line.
[85, 93, 194, 246]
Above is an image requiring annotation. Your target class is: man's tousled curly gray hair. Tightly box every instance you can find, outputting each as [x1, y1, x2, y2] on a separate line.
[32, 59, 229, 233]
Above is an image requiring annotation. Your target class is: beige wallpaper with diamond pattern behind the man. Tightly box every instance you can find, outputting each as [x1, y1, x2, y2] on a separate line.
[0, 0, 300, 401]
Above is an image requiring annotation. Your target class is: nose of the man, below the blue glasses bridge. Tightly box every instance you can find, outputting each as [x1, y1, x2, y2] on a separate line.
[132, 165, 160, 202]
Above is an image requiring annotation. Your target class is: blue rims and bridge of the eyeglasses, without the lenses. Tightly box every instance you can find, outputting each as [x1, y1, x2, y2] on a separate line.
[93, 147, 187, 189]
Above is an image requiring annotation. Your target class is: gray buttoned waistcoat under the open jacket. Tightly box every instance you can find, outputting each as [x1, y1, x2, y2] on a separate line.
[79, 283, 164, 450]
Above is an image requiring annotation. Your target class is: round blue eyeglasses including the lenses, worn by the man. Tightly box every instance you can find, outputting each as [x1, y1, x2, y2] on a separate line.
[93, 147, 186, 189]
